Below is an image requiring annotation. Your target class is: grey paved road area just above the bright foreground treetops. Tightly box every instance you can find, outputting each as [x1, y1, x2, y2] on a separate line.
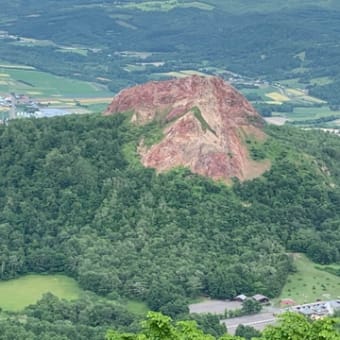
[221, 312, 276, 334]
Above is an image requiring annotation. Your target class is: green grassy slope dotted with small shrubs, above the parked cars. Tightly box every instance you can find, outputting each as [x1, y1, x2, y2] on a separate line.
[277, 254, 340, 303]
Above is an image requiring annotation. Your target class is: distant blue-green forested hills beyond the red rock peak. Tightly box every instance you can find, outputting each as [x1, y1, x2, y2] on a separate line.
[0, 0, 340, 99]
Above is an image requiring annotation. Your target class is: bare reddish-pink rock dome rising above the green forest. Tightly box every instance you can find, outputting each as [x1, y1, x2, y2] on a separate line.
[105, 76, 268, 180]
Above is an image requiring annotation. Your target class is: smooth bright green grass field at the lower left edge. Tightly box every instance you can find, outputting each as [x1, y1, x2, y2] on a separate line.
[0, 275, 82, 311]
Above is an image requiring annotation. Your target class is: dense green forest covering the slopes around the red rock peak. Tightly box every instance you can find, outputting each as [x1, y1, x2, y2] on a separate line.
[0, 114, 340, 339]
